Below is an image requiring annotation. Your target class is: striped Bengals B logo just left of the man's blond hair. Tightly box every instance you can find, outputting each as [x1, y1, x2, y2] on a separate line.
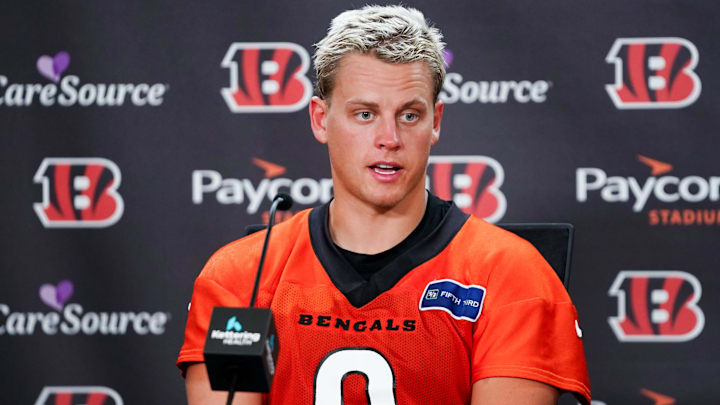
[220, 42, 312, 113]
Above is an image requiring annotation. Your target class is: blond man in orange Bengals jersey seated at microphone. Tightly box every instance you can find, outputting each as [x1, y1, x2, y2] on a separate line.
[178, 6, 590, 405]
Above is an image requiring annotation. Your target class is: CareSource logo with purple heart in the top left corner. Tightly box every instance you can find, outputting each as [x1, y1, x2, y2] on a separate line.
[0, 51, 170, 107]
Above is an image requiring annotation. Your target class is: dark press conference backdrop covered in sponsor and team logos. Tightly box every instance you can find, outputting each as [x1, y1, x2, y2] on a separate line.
[0, 0, 720, 405]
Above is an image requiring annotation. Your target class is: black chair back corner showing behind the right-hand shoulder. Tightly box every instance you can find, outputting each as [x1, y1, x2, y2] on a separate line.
[498, 223, 573, 290]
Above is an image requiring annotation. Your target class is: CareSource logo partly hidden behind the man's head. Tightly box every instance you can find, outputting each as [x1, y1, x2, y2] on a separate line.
[439, 49, 552, 104]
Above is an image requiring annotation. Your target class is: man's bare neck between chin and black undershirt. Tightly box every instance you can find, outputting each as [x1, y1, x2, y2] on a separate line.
[329, 189, 427, 254]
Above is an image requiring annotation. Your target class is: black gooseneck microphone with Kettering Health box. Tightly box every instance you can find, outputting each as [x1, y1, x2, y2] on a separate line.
[203, 193, 293, 405]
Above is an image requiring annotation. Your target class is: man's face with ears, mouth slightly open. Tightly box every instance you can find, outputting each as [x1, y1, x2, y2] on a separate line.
[310, 54, 443, 210]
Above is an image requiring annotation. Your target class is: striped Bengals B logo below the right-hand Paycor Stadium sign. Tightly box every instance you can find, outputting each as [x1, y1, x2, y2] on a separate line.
[608, 270, 705, 342]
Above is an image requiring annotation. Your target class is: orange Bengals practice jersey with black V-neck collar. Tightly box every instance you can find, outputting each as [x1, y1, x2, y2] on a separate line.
[177, 205, 590, 405]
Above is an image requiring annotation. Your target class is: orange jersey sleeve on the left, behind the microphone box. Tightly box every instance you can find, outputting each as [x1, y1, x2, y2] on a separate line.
[177, 240, 256, 376]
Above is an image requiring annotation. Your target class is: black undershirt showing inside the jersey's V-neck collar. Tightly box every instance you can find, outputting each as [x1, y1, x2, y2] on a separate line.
[335, 193, 452, 280]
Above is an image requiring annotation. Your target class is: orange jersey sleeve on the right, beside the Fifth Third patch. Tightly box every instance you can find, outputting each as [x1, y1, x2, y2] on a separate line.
[472, 235, 590, 403]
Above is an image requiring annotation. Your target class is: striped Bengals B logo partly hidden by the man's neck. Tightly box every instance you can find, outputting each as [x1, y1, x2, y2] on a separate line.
[427, 156, 507, 223]
